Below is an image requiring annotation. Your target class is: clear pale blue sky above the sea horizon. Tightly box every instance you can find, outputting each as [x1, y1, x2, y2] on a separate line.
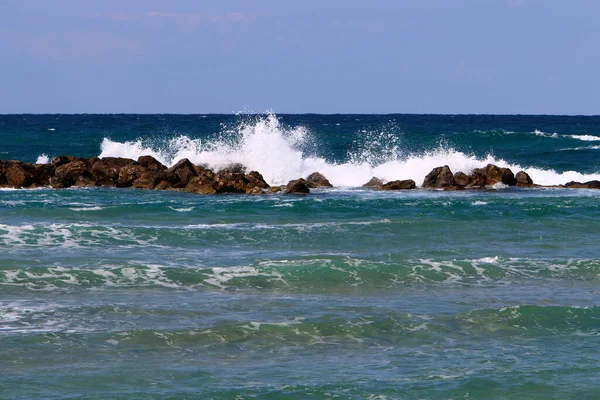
[0, 0, 600, 115]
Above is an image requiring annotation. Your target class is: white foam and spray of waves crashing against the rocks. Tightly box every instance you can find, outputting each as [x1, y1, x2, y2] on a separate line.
[100, 114, 600, 187]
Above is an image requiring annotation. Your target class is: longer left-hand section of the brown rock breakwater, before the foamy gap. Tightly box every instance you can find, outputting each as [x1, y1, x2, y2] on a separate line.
[0, 156, 316, 194]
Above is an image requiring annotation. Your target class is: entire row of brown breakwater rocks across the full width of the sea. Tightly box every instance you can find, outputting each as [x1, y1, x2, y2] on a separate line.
[0, 156, 600, 194]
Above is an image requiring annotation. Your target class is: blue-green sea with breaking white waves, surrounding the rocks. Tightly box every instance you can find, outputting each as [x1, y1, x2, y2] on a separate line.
[0, 112, 600, 400]
